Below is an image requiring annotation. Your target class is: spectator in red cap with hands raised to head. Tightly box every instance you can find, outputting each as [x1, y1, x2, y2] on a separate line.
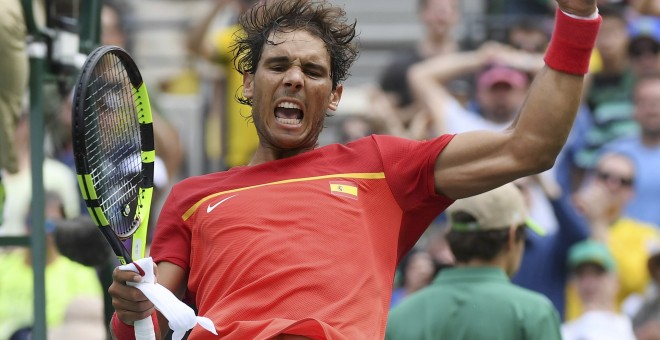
[409, 43, 557, 230]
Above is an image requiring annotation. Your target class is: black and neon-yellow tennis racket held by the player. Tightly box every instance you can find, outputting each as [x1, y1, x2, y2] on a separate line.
[72, 46, 156, 340]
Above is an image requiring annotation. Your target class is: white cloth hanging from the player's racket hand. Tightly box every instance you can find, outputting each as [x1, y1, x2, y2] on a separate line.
[119, 257, 218, 340]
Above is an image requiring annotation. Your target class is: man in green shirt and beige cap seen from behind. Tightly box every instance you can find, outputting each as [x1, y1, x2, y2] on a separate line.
[385, 184, 561, 340]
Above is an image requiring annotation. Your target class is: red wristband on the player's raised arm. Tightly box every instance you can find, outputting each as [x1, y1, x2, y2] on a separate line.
[545, 8, 603, 75]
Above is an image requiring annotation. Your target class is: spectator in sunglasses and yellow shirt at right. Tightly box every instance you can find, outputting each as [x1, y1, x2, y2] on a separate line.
[566, 153, 658, 320]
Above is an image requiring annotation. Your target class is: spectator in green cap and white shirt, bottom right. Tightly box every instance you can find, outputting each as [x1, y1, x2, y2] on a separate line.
[561, 240, 635, 340]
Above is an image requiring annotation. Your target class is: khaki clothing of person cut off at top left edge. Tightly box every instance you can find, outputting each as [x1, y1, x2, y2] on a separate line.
[0, 0, 29, 173]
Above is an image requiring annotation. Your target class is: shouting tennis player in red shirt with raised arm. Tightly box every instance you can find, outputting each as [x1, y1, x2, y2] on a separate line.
[109, 0, 601, 339]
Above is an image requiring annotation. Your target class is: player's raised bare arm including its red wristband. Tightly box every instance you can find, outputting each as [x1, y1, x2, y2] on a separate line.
[435, 0, 601, 199]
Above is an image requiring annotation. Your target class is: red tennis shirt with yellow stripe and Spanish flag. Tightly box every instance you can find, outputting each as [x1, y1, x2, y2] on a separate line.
[151, 135, 452, 340]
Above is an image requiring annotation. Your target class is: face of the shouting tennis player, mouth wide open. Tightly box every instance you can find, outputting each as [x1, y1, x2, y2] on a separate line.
[243, 30, 342, 153]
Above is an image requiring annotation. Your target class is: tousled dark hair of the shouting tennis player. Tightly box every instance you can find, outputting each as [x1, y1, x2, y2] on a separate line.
[234, 0, 359, 105]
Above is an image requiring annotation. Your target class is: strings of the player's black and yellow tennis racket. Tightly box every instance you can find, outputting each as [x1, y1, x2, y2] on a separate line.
[85, 54, 142, 237]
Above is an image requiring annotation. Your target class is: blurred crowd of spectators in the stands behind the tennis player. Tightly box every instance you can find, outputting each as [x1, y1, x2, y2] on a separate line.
[0, 0, 660, 339]
